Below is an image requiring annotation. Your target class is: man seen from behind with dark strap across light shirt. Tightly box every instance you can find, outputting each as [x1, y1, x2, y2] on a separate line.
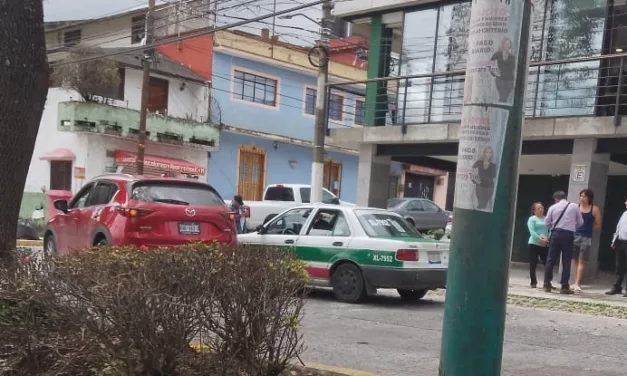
[544, 191, 583, 294]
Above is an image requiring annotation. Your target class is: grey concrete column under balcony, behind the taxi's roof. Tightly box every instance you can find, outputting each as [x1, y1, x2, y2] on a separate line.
[357, 144, 392, 208]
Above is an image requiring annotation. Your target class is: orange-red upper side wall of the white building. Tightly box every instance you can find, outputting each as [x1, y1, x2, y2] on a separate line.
[157, 34, 213, 80]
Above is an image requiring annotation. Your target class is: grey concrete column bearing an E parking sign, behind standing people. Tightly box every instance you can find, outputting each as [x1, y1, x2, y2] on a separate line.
[560, 138, 610, 283]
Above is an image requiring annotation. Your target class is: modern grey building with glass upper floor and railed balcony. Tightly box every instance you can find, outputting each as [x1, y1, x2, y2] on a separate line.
[328, 0, 627, 273]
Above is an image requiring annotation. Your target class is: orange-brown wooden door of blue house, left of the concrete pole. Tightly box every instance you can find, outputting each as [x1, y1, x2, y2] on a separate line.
[237, 146, 266, 202]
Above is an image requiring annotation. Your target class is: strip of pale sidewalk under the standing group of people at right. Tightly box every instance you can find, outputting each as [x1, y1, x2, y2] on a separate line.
[509, 263, 627, 307]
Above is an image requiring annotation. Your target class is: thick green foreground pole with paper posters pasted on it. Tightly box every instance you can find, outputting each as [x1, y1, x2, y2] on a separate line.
[439, 0, 532, 376]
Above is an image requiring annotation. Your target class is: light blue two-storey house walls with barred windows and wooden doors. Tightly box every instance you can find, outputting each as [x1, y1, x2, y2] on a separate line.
[208, 31, 365, 202]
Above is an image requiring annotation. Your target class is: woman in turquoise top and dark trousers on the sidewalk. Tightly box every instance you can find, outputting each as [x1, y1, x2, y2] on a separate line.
[527, 202, 549, 289]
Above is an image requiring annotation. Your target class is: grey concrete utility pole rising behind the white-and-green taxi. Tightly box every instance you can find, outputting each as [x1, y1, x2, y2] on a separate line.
[310, 0, 333, 202]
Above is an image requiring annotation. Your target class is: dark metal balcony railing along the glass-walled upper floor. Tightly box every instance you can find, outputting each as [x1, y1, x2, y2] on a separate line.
[328, 54, 627, 133]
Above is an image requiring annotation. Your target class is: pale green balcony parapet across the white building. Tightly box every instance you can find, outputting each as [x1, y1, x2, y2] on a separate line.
[58, 102, 220, 150]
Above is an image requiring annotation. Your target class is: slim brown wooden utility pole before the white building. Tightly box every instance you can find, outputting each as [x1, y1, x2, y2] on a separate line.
[137, 0, 155, 175]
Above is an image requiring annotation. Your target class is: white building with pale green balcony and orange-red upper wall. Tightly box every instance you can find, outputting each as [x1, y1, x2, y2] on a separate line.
[20, 1, 220, 218]
